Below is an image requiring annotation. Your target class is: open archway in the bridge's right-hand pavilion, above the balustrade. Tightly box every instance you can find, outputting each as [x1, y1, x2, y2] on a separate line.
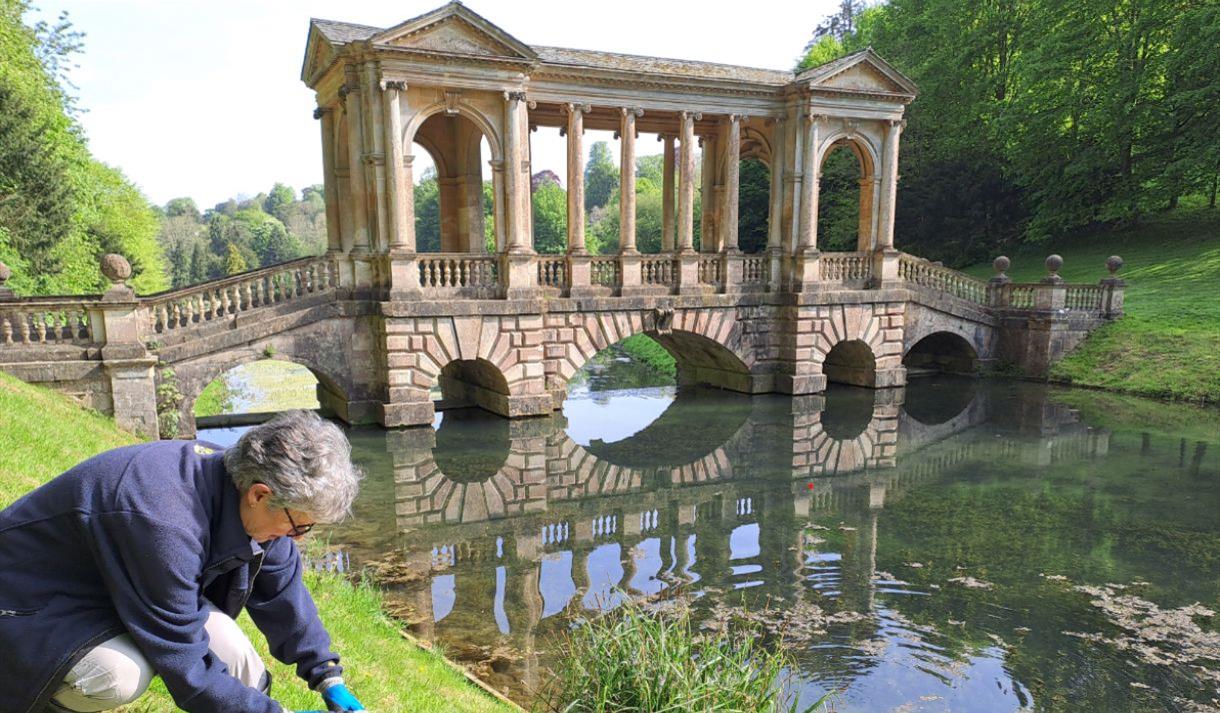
[817, 137, 881, 252]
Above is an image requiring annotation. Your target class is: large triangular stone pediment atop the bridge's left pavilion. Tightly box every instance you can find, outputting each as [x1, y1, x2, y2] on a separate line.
[371, 2, 537, 60]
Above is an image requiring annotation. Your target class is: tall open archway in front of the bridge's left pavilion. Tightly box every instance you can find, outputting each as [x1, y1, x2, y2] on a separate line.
[406, 112, 492, 254]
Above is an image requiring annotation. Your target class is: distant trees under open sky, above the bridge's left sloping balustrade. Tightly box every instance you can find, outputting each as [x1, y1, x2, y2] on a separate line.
[159, 183, 327, 288]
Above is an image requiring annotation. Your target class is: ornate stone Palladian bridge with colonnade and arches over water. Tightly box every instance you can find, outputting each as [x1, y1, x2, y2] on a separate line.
[0, 2, 1122, 436]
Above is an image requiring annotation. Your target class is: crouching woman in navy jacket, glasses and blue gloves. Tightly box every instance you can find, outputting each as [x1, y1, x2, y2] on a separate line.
[0, 411, 364, 713]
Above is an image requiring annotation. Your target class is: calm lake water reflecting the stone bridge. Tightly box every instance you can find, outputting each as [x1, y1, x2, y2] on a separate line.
[204, 364, 1220, 712]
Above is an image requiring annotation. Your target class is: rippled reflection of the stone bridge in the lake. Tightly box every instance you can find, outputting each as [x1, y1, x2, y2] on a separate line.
[322, 380, 1109, 698]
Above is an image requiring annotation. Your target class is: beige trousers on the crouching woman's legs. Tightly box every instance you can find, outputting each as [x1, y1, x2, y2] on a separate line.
[51, 602, 267, 713]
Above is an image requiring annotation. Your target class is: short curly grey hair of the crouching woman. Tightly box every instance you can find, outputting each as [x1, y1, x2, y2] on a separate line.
[224, 411, 364, 523]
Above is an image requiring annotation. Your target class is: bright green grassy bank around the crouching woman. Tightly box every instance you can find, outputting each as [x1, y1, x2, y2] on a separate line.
[0, 372, 511, 713]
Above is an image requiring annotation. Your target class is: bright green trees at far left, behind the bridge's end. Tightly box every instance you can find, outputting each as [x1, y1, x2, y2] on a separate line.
[0, 0, 168, 294]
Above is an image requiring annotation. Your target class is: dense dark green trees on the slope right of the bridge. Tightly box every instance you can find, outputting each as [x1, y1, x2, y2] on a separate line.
[799, 0, 1220, 265]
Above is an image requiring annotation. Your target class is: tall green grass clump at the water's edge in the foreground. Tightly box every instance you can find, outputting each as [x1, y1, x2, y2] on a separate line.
[545, 601, 820, 713]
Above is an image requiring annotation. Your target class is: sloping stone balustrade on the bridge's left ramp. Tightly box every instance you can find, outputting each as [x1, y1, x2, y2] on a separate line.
[140, 258, 339, 335]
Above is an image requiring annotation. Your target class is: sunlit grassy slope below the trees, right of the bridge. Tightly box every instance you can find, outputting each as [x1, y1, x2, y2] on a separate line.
[966, 209, 1220, 404]
